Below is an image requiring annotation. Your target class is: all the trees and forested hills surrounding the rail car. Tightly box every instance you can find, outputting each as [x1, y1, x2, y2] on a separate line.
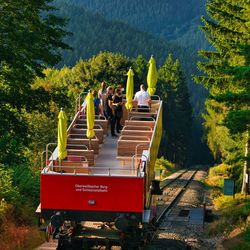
[0, 0, 250, 249]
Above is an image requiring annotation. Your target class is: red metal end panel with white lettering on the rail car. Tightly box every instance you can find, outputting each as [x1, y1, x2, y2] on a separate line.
[40, 174, 144, 212]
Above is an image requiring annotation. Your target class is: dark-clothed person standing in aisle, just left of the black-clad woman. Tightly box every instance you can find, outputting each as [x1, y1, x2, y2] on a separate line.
[104, 87, 117, 137]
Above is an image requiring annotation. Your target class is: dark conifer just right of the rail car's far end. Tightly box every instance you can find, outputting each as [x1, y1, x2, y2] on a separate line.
[158, 55, 192, 166]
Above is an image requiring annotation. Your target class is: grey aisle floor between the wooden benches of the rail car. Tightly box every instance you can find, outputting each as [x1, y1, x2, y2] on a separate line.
[92, 135, 136, 176]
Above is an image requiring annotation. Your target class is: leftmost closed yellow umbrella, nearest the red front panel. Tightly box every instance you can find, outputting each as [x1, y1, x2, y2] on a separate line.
[57, 109, 67, 160]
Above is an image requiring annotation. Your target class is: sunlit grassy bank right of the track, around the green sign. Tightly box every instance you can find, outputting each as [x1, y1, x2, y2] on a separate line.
[205, 164, 250, 247]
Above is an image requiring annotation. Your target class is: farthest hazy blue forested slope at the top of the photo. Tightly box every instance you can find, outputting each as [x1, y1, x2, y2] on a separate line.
[63, 0, 208, 49]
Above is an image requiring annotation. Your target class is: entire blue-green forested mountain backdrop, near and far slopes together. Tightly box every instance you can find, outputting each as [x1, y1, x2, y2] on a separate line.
[52, 0, 211, 163]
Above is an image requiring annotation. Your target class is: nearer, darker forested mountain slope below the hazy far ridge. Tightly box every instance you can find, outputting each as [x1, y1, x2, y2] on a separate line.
[52, 0, 211, 163]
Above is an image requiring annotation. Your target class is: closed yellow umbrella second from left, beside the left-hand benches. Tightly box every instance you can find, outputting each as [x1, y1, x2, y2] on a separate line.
[86, 93, 95, 139]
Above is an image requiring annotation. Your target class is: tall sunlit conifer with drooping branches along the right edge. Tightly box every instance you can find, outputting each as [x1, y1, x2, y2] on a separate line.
[196, 0, 250, 191]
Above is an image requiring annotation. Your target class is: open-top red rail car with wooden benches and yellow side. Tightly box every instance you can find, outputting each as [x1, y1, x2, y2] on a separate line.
[37, 96, 162, 249]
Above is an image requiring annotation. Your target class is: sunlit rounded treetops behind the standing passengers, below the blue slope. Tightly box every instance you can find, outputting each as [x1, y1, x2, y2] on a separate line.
[34, 52, 132, 101]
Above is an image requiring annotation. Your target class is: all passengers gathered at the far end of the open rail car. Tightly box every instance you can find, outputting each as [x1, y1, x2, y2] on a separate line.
[82, 82, 151, 137]
